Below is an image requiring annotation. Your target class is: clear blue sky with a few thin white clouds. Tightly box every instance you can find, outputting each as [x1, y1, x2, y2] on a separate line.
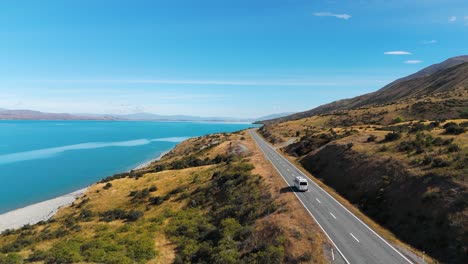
[0, 0, 468, 117]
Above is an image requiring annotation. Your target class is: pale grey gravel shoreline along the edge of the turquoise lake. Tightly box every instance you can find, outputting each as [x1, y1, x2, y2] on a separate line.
[0, 149, 172, 234]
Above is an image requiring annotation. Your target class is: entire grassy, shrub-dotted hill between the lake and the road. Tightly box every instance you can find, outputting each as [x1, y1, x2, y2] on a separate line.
[0, 132, 328, 263]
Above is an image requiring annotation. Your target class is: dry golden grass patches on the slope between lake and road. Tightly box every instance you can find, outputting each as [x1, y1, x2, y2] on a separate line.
[0, 131, 327, 263]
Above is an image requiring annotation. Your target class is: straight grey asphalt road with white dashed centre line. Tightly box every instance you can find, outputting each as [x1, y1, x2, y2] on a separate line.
[250, 130, 413, 264]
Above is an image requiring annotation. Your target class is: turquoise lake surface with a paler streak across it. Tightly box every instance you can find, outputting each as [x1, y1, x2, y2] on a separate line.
[0, 121, 254, 214]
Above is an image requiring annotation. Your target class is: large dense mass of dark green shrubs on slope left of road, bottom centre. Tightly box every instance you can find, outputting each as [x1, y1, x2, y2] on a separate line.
[166, 162, 284, 263]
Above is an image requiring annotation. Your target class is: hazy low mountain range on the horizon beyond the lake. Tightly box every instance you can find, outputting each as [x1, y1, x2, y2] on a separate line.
[0, 108, 292, 122]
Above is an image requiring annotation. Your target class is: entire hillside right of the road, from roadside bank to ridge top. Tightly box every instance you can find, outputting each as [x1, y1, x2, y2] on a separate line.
[260, 59, 468, 263]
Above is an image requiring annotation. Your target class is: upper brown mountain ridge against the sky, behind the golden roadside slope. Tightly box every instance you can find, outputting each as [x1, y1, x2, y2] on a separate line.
[260, 56, 468, 124]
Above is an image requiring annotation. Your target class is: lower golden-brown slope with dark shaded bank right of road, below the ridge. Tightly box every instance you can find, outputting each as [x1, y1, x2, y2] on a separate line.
[260, 116, 468, 263]
